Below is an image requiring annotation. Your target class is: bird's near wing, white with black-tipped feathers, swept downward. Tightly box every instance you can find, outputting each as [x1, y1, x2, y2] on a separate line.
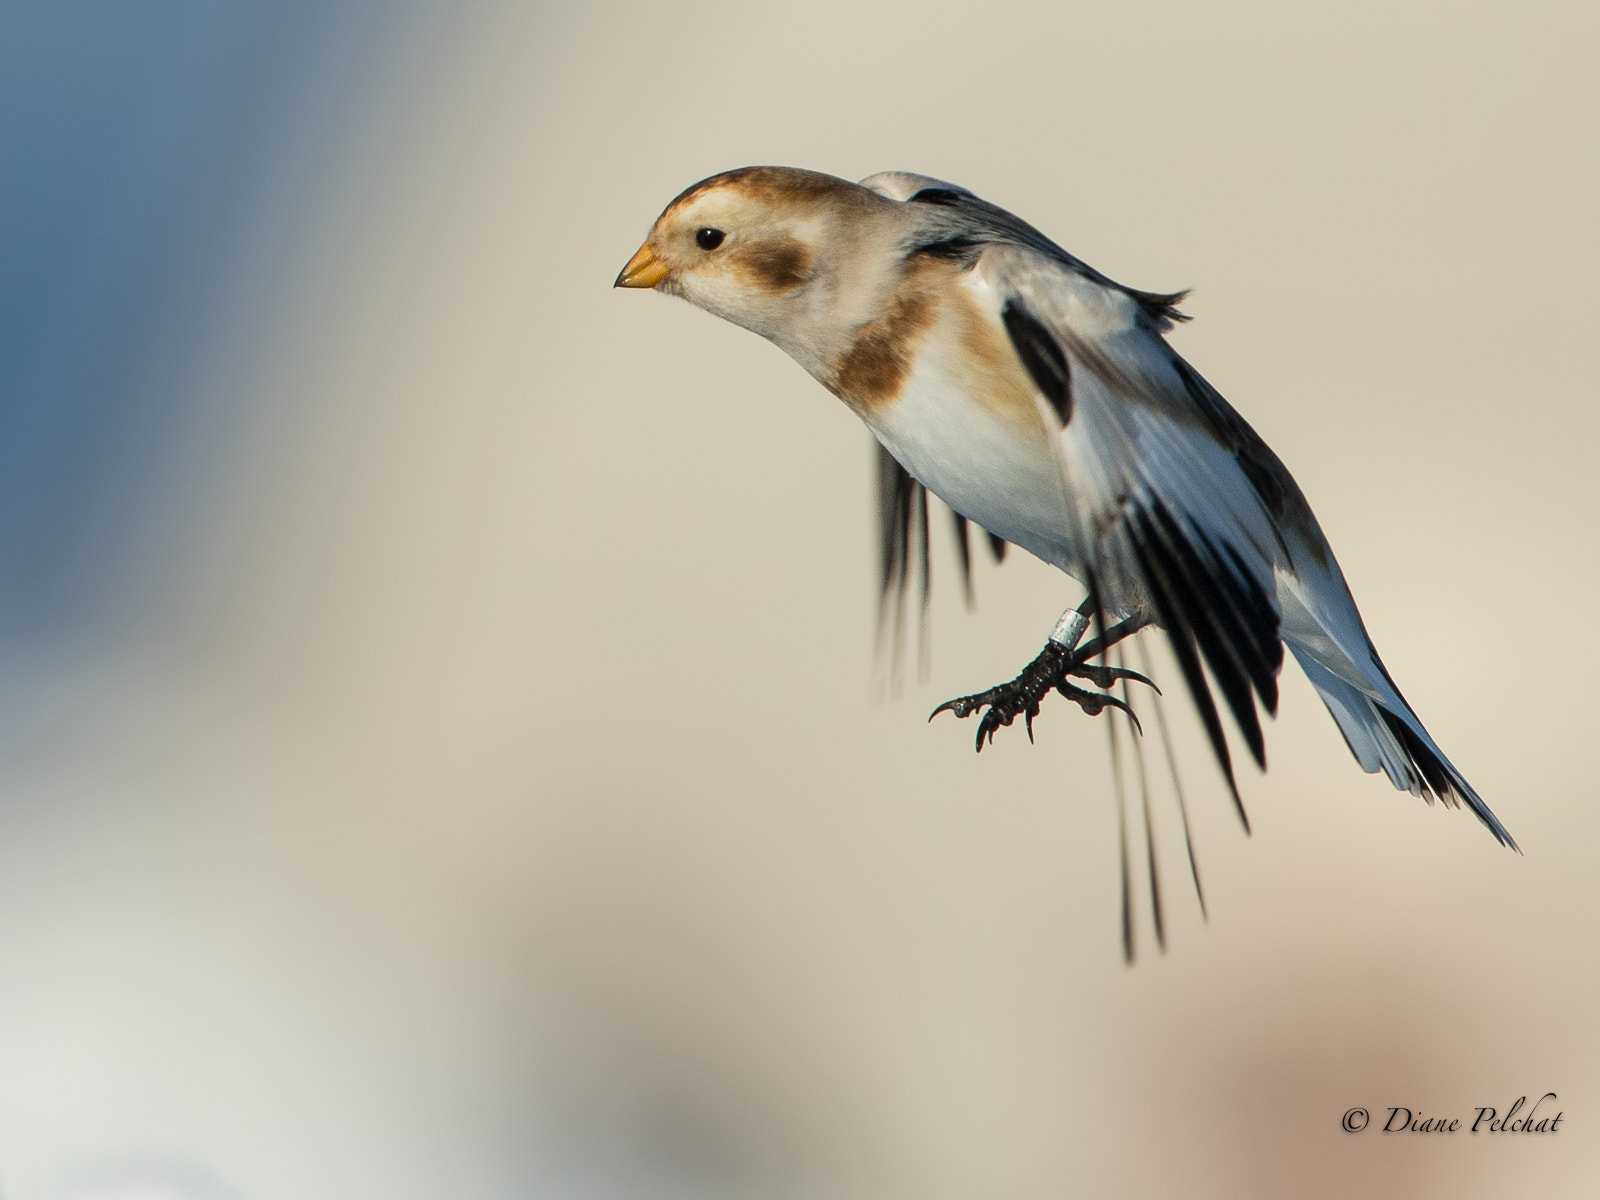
[963, 238, 1292, 812]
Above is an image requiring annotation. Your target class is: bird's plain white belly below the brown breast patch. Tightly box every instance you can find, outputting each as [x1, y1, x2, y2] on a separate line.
[862, 358, 1082, 574]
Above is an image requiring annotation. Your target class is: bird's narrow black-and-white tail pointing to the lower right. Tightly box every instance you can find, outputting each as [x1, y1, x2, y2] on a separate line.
[1283, 630, 1517, 850]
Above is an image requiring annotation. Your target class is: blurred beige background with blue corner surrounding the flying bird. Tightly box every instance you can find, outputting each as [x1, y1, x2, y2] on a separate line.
[0, 0, 1600, 1200]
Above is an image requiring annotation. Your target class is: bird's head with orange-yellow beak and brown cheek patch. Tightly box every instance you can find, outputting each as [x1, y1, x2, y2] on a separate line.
[616, 166, 896, 363]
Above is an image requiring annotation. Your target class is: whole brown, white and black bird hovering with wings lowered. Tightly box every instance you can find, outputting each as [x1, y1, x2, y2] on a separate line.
[616, 166, 1517, 957]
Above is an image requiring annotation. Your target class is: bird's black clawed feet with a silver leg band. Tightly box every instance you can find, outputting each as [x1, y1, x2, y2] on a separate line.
[928, 600, 1155, 750]
